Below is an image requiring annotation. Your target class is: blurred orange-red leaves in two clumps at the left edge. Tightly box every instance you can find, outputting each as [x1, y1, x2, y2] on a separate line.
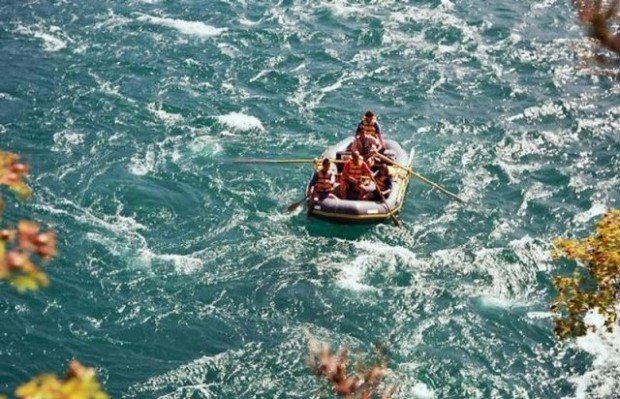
[0, 151, 56, 292]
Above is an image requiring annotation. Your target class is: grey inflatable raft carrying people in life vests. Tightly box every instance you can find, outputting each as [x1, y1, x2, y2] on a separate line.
[306, 138, 413, 223]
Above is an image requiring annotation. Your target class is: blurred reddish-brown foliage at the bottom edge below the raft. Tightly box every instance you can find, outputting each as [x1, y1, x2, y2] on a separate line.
[306, 332, 396, 399]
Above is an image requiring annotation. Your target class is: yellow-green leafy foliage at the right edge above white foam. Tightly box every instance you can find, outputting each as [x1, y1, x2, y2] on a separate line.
[551, 209, 620, 338]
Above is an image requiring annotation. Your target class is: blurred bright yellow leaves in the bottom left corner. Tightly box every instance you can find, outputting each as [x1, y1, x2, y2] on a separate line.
[15, 360, 108, 399]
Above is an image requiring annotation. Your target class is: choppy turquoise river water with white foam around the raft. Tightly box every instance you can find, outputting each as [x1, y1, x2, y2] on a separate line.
[0, 0, 620, 398]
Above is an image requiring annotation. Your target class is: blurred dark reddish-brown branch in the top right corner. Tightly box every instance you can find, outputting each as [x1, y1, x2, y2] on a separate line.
[573, 0, 620, 55]
